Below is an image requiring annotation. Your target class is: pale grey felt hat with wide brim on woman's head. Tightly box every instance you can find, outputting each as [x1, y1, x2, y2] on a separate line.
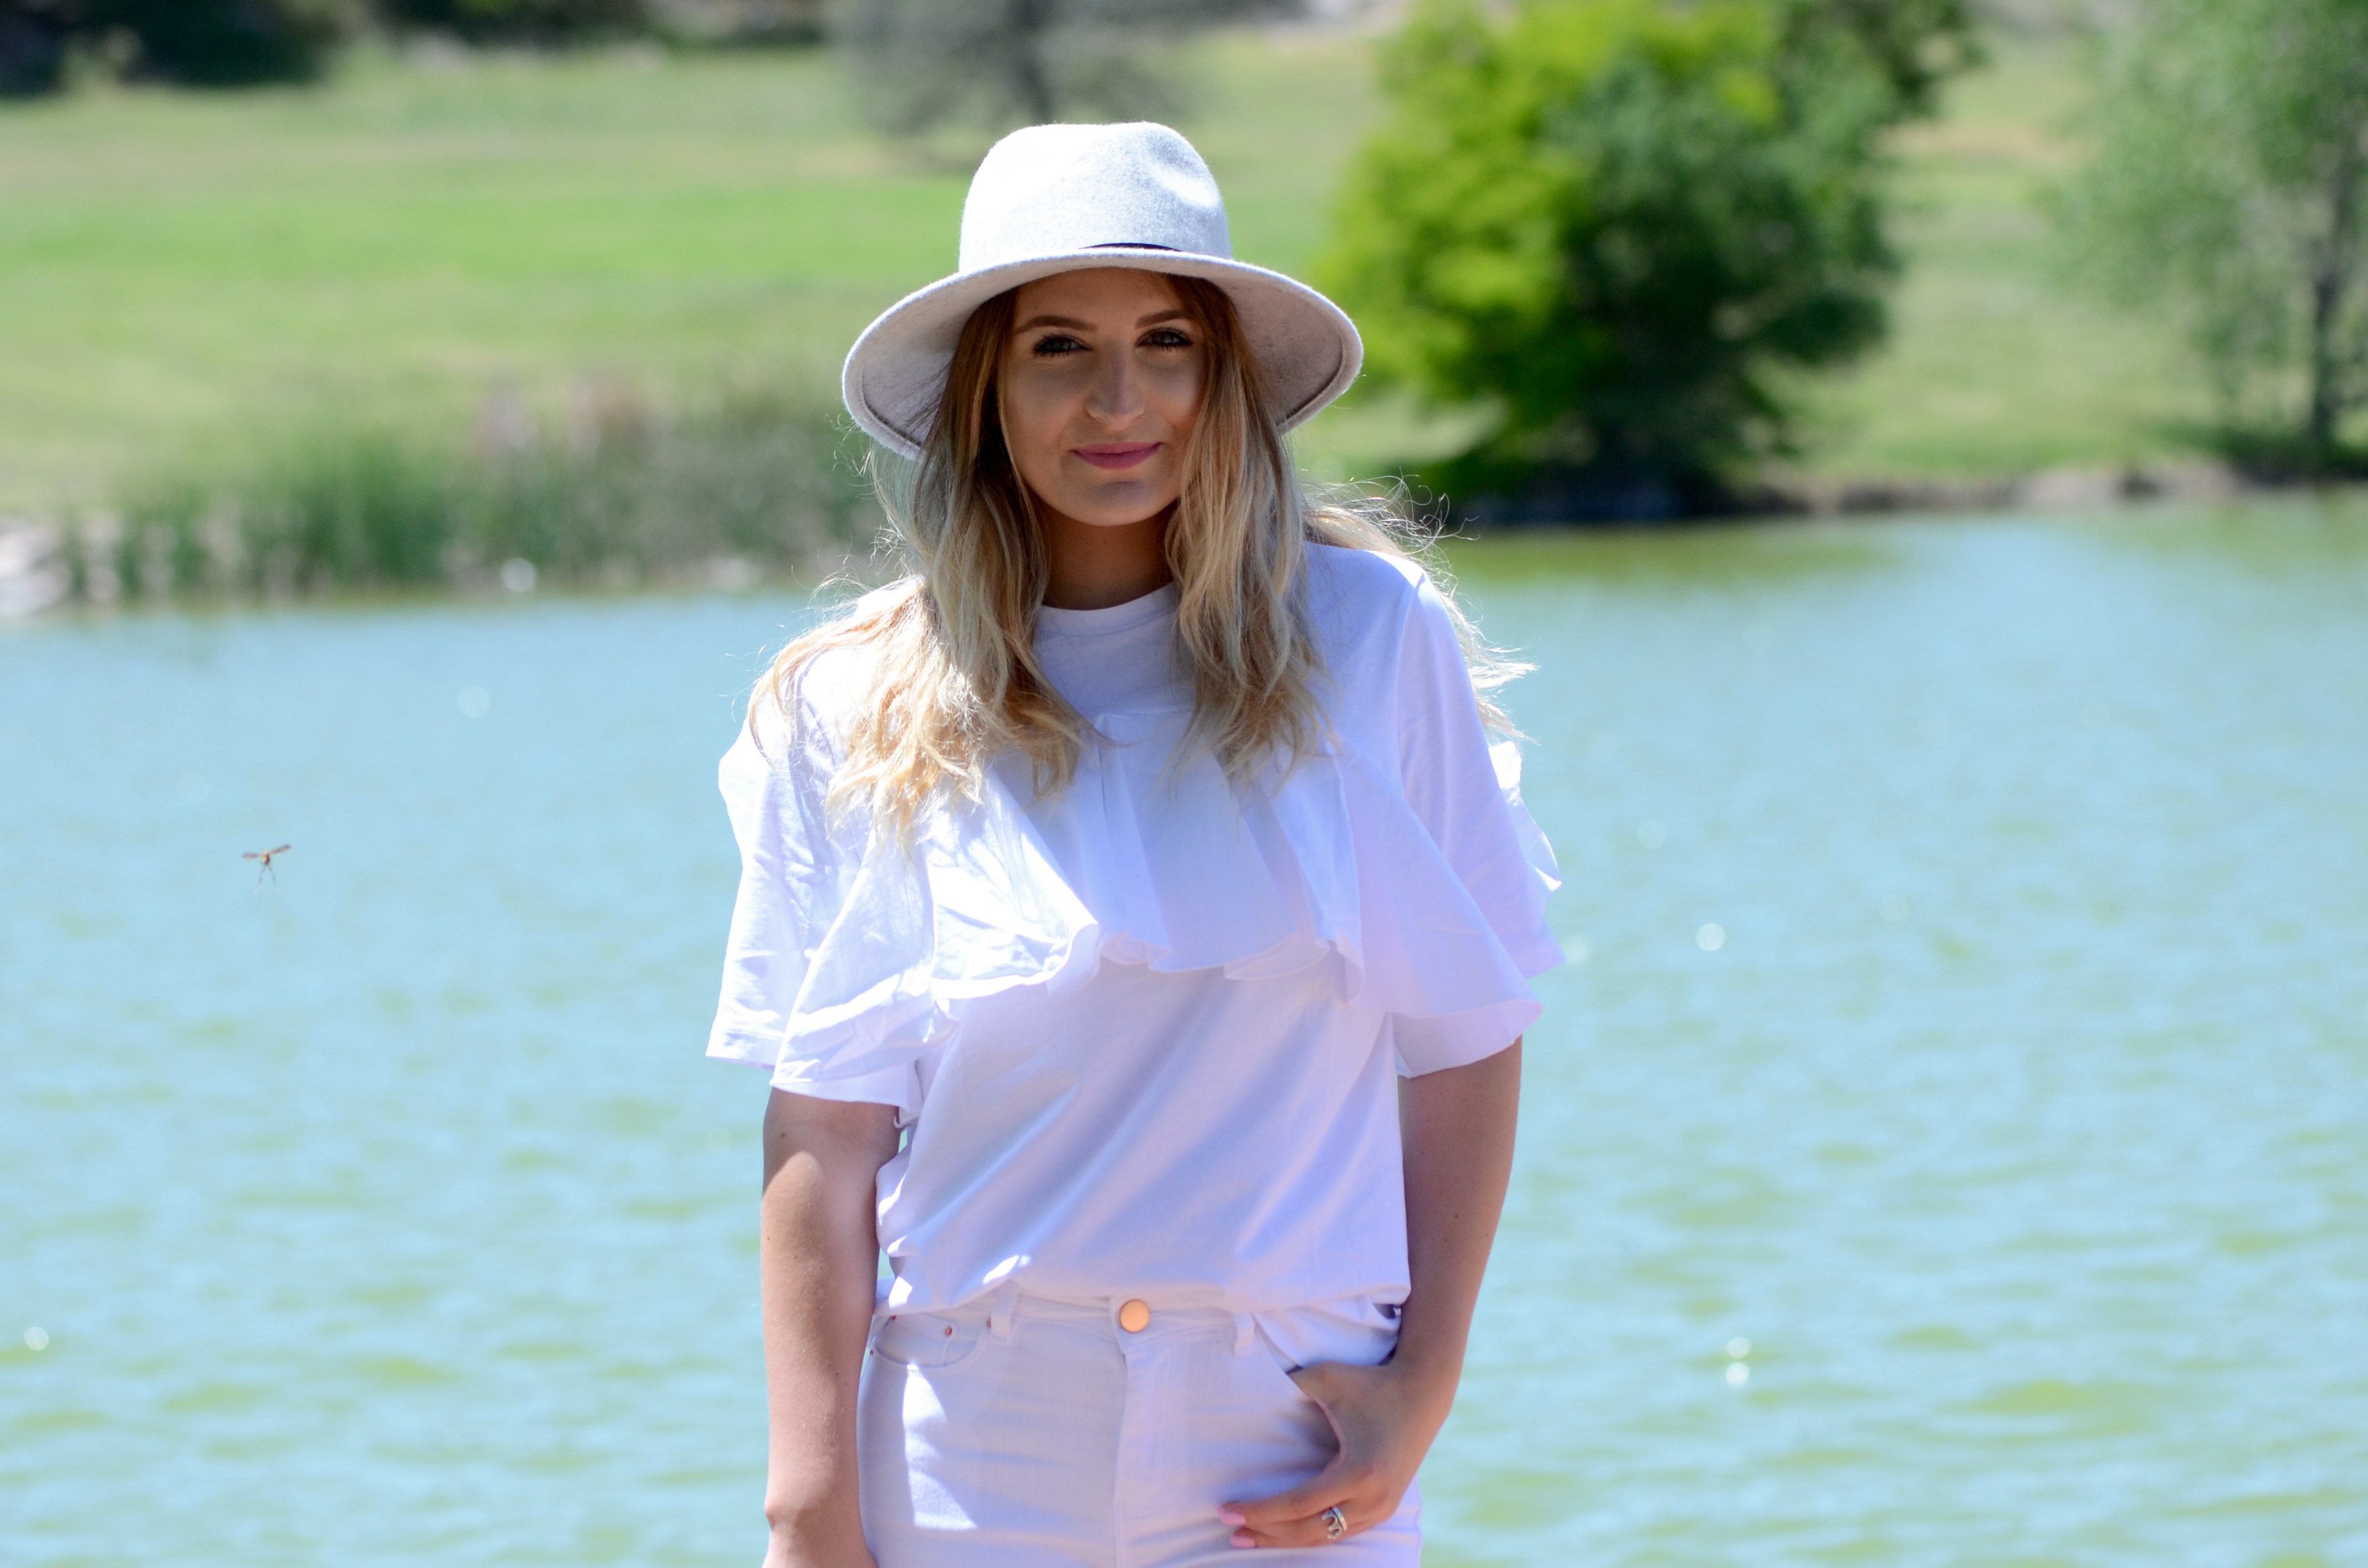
[841, 123, 1364, 457]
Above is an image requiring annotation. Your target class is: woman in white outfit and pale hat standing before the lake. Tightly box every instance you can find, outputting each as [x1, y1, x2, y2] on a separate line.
[708, 126, 1561, 1568]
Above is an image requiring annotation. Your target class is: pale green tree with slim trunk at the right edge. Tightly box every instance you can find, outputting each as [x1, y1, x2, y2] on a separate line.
[2058, 0, 2368, 469]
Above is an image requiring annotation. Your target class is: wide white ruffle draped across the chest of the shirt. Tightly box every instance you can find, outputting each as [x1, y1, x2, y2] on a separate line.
[775, 713, 1561, 1087]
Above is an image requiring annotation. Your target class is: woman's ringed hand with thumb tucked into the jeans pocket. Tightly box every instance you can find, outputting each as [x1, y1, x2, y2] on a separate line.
[1217, 1362, 1456, 1547]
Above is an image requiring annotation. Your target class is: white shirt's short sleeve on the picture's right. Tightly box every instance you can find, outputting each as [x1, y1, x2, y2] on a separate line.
[1390, 578, 1563, 1075]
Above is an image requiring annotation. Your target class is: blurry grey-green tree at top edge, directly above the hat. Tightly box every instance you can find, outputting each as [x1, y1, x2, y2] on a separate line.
[826, 0, 1297, 133]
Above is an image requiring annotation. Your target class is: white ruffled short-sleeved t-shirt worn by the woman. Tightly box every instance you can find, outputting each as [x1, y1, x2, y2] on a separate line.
[708, 547, 1561, 1314]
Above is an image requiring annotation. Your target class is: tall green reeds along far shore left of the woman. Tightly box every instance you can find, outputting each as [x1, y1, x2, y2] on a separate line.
[109, 386, 869, 594]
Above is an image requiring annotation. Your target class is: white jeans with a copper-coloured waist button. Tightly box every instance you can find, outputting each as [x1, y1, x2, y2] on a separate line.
[857, 1296, 1423, 1568]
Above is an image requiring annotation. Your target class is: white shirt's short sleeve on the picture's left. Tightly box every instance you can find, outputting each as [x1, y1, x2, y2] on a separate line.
[708, 682, 928, 1120]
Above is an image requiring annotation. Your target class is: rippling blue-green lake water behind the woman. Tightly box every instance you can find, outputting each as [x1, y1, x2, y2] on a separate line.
[0, 505, 2368, 1568]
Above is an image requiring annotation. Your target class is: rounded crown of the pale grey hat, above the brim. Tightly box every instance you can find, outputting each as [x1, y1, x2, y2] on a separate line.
[957, 121, 1234, 272]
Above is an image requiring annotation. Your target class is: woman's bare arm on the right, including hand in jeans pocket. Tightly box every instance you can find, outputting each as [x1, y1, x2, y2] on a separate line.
[1219, 1040, 1520, 1547]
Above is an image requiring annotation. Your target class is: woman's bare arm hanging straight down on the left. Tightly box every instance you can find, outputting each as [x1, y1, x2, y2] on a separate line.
[758, 1090, 895, 1568]
